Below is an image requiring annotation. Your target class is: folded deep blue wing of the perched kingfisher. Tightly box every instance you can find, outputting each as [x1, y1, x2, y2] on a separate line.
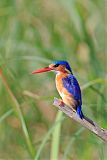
[62, 74, 82, 105]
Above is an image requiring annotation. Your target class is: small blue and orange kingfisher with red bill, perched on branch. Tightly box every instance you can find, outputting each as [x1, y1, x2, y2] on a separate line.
[32, 60, 84, 119]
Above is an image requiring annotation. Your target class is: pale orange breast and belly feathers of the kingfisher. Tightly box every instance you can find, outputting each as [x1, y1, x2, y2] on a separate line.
[56, 73, 77, 110]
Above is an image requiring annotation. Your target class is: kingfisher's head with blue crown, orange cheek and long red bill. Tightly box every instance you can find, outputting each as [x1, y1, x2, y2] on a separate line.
[32, 60, 72, 74]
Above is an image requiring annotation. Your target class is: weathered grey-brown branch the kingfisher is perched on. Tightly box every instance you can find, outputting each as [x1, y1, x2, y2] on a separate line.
[53, 98, 107, 142]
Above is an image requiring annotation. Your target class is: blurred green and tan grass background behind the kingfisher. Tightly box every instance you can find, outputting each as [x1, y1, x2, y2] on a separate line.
[0, 0, 107, 160]
